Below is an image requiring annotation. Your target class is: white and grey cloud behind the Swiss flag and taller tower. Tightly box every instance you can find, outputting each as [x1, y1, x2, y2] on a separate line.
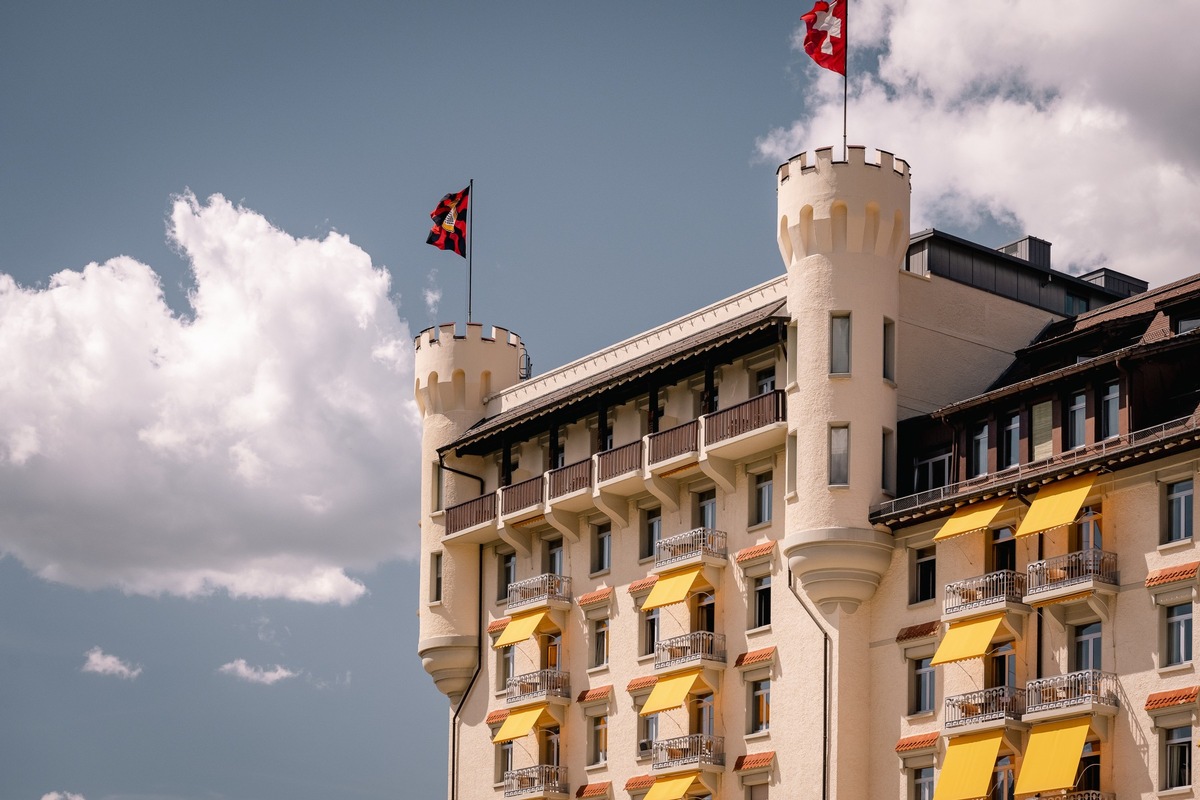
[758, 0, 1200, 284]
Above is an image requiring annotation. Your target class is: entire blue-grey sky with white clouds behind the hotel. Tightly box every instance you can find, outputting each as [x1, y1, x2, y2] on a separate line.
[7, 0, 1200, 800]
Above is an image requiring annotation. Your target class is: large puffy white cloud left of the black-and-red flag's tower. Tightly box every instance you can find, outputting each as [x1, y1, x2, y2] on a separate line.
[0, 196, 419, 603]
